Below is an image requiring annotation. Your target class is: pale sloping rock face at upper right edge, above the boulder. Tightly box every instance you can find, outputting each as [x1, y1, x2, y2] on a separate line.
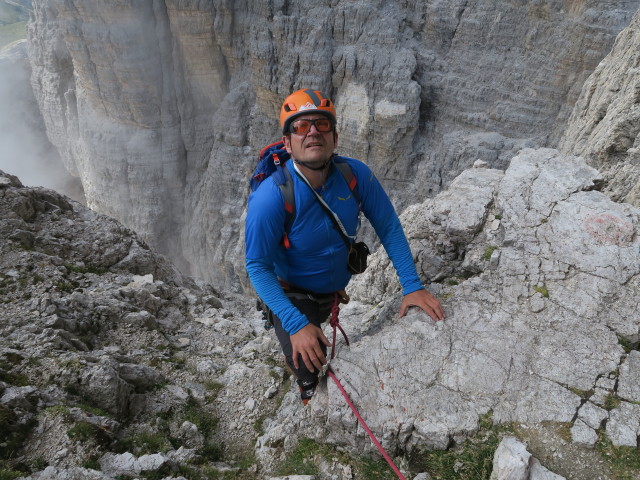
[560, 7, 640, 206]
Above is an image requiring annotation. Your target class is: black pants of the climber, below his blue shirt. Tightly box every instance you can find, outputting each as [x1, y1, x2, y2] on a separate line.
[270, 291, 334, 389]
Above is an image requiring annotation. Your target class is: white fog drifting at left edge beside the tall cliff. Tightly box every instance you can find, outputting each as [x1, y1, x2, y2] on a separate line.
[0, 41, 84, 201]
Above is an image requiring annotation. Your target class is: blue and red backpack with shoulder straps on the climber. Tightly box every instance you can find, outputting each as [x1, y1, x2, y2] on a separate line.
[249, 141, 360, 248]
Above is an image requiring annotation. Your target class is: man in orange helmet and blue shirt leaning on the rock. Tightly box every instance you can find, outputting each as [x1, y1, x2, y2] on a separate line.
[245, 89, 444, 405]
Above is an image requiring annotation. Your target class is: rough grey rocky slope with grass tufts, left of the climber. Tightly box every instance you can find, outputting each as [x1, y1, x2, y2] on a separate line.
[0, 171, 285, 479]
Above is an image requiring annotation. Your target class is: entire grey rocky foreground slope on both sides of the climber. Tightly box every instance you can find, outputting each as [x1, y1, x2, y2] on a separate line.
[0, 149, 640, 480]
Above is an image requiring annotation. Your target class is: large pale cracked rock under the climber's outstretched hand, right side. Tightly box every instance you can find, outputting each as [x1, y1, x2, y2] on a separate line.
[258, 149, 640, 461]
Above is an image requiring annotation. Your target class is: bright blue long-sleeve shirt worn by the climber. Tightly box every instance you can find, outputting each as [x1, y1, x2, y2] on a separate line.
[245, 157, 422, 335]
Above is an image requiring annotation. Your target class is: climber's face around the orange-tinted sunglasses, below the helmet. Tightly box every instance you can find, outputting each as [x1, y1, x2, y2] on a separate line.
[282, 113, 338, 166]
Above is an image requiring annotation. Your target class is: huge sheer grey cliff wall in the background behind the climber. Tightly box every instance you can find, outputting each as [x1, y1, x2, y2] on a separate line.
[28, 0, 640, 288]
